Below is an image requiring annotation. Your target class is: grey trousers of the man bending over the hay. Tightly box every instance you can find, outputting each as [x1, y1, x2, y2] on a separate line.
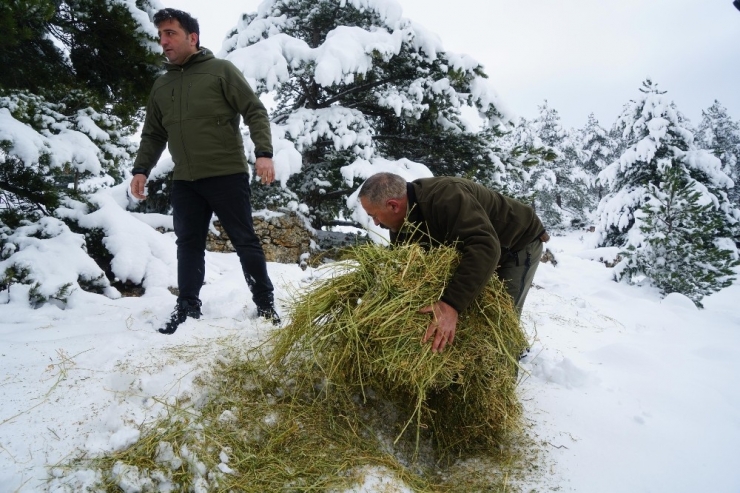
[496, 238, 543, 317]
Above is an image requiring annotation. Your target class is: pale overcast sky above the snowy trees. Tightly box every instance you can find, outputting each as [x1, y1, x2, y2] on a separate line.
[169, 0, 740, 127]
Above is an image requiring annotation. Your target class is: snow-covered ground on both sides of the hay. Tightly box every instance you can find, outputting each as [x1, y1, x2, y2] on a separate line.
[0, 232, 740, 493]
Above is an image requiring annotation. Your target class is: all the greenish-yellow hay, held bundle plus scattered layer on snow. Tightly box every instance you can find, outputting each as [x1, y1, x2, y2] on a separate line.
[56, 241, 535, 492]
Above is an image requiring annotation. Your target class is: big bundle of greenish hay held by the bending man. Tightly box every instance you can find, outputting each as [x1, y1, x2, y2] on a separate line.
[271, 244, 527, 455]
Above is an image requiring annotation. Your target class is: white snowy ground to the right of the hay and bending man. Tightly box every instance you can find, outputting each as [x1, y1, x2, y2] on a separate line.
[522, 234, 740, 492]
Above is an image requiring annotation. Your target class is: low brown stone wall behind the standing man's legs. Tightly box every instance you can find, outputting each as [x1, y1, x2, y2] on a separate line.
[206, 211, 316, 265]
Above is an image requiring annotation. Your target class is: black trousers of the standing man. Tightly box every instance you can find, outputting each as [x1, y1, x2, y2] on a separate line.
[171, 173, 273, 306]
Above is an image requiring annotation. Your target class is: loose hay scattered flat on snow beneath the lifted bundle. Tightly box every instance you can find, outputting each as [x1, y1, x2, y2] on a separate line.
[76, 352, 536, 493]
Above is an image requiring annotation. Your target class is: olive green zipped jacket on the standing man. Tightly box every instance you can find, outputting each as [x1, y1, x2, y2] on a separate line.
[134, 48, 272, 180]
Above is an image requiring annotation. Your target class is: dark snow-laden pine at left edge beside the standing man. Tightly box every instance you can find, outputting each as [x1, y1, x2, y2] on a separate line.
[0, 0, 159, 303]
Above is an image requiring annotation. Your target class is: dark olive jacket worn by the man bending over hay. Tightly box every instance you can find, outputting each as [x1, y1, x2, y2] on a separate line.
[391, 177, 545, 312]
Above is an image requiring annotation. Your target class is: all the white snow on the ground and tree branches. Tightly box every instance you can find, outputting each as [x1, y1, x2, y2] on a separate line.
[0, 0, 740, 493]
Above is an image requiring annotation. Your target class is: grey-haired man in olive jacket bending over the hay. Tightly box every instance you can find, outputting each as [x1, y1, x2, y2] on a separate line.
[359, 173, 549, 352]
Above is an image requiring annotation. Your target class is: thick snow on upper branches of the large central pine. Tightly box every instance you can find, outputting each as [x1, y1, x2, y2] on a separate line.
[223, 0, 514, 125]
